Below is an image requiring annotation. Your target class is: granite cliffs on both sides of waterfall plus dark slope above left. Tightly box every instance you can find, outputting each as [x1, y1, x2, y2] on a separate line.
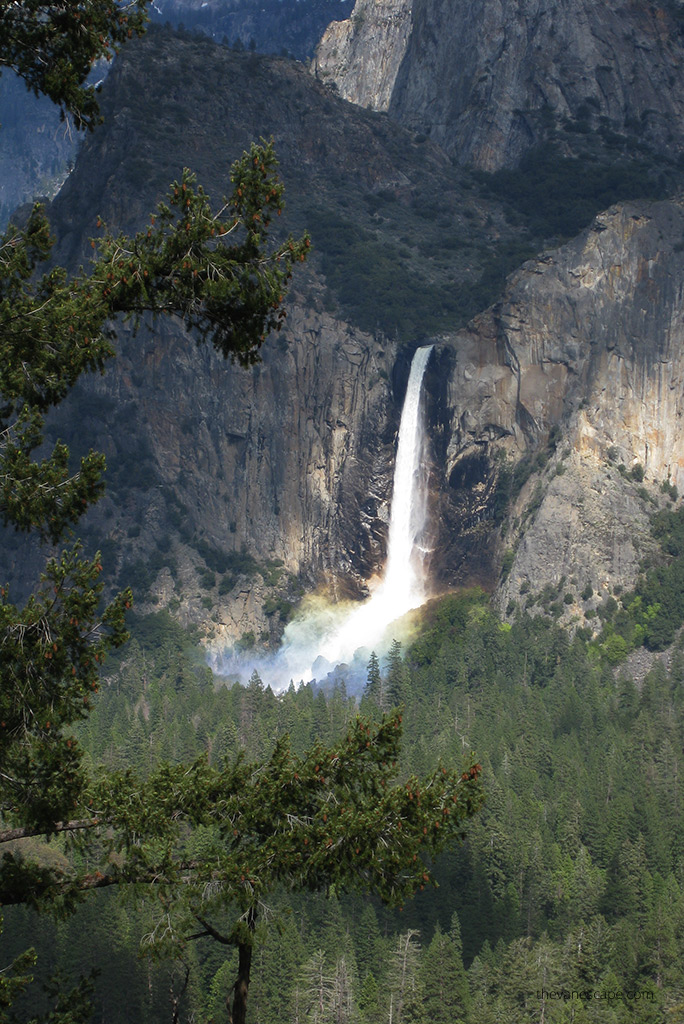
[4, 30, 684, 655]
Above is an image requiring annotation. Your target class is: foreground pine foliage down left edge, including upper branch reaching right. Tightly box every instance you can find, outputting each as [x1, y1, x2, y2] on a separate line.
[0, 136, 306, 826]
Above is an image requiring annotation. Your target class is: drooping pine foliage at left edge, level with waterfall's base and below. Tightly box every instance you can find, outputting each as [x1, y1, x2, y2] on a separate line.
[0, 545, 131, 833]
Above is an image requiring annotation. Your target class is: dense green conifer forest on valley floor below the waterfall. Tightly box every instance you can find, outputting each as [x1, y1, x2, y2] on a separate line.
[2, 592, 684, 1024]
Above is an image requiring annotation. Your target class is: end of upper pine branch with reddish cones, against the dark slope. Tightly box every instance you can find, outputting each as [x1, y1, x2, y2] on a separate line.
[89, 143, 309, 366]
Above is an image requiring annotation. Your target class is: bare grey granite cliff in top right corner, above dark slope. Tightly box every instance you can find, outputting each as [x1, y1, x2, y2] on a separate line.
[315, 0, 684, 171]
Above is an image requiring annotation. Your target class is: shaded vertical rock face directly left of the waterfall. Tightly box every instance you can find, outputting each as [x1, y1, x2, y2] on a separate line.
[55, 306, 395, 639]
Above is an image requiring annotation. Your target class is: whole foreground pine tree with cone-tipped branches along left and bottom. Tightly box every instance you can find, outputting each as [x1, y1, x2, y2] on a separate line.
[0, 9, 489, 1024]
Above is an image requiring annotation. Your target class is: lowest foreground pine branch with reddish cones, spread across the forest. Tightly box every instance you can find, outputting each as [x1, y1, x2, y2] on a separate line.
[82, 714, 481, 913]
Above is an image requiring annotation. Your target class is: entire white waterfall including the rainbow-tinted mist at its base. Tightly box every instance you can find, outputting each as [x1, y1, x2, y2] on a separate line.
[212, 345, 432, 693]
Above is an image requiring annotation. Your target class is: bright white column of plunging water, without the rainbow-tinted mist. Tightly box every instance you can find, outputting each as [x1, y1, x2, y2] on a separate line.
[309, 345, 432, 665]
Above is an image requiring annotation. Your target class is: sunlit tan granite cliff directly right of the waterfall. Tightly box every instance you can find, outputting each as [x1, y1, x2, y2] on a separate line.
[433, 201, 684, 606]
